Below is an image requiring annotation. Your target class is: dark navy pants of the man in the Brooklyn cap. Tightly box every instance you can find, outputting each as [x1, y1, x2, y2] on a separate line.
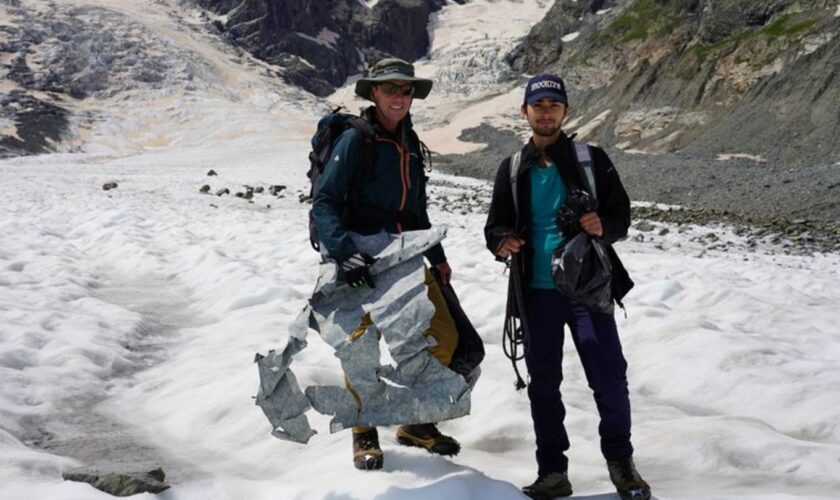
[525, 289, 633, 474]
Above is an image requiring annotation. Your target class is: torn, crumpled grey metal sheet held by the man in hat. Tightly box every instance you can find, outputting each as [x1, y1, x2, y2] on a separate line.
[257, 228, 470, 443]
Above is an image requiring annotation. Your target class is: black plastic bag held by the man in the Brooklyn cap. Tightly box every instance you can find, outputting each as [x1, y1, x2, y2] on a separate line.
[551, 232, 613, 314]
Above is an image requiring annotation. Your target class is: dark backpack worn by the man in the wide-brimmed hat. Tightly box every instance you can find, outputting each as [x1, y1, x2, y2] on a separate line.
[306, 107, 375, 251]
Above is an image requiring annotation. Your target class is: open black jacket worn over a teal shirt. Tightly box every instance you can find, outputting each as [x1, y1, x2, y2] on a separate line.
[484, 134, 633, 316]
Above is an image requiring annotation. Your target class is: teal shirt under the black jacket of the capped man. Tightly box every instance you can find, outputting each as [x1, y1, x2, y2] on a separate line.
[529, 163, 566, 289]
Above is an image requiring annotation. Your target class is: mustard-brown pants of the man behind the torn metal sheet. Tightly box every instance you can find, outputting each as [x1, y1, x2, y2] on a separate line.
[344, 269, 458, 432]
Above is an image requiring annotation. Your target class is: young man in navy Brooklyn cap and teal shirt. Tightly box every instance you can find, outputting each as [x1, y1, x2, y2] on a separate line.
[484, 74, 650, 499]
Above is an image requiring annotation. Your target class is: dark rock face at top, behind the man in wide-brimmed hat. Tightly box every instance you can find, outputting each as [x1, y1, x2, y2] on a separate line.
[194, 0, 463, 96]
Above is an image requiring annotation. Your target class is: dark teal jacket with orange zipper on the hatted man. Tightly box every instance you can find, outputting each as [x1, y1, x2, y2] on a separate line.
[312, 106, 446, 265]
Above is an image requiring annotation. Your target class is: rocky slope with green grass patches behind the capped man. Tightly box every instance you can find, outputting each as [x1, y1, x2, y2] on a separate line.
[509, 0, 840, 165]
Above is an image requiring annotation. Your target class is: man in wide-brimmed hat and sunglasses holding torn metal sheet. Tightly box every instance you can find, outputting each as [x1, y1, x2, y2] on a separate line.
[312, 59, 461, 470]
